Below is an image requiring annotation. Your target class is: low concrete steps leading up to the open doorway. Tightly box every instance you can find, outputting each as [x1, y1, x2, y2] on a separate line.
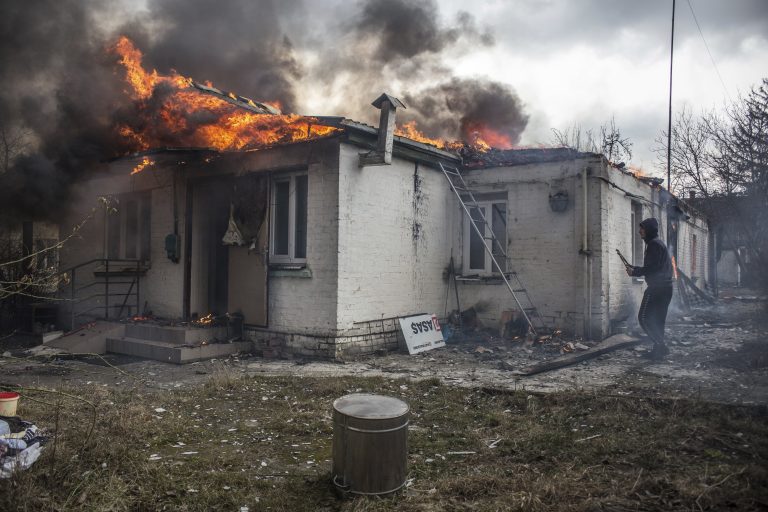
[106, 323, 253, 364]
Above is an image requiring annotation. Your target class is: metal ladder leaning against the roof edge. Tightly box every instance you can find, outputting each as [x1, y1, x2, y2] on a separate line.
[440, 162, 548, 335]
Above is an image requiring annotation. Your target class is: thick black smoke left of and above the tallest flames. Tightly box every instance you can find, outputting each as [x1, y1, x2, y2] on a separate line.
[0, 0, 303, 219]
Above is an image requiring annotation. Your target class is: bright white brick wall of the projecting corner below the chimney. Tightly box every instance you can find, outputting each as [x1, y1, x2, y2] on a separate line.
[248, 140, 455, 357]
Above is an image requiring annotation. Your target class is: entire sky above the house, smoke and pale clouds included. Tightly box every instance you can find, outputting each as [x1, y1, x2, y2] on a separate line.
[0, 0, 768, 189]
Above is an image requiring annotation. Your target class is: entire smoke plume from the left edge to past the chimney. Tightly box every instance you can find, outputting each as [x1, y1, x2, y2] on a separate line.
[0, 0, 528, 219]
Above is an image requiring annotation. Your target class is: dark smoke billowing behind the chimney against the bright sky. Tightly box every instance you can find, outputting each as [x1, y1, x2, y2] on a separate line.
[308, 0, 528, 143]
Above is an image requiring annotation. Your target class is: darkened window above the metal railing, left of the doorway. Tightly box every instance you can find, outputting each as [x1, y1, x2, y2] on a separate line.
[107, 193, 152, 261]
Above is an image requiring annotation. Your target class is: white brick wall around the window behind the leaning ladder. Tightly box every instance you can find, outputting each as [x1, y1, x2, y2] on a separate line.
[454, 161, 594, 332]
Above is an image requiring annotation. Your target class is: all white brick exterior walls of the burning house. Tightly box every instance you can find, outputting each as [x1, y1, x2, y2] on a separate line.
[62, 139, 707, 357]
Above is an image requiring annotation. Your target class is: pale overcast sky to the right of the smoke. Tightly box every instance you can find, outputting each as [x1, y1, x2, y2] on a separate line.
[286, 0, 768, 172]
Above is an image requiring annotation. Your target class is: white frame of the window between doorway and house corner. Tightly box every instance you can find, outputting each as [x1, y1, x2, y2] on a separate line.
[269, 171, 309, 266]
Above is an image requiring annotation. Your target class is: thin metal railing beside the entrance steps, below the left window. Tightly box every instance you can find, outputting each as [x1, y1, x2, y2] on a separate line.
[59, 258, 144, 329]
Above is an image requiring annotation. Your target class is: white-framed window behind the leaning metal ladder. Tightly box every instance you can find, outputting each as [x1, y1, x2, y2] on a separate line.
[464, 202, 507, 274]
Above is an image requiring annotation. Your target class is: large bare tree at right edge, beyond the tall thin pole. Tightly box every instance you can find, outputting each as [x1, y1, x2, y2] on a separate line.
[654, 79, 768, 289]
